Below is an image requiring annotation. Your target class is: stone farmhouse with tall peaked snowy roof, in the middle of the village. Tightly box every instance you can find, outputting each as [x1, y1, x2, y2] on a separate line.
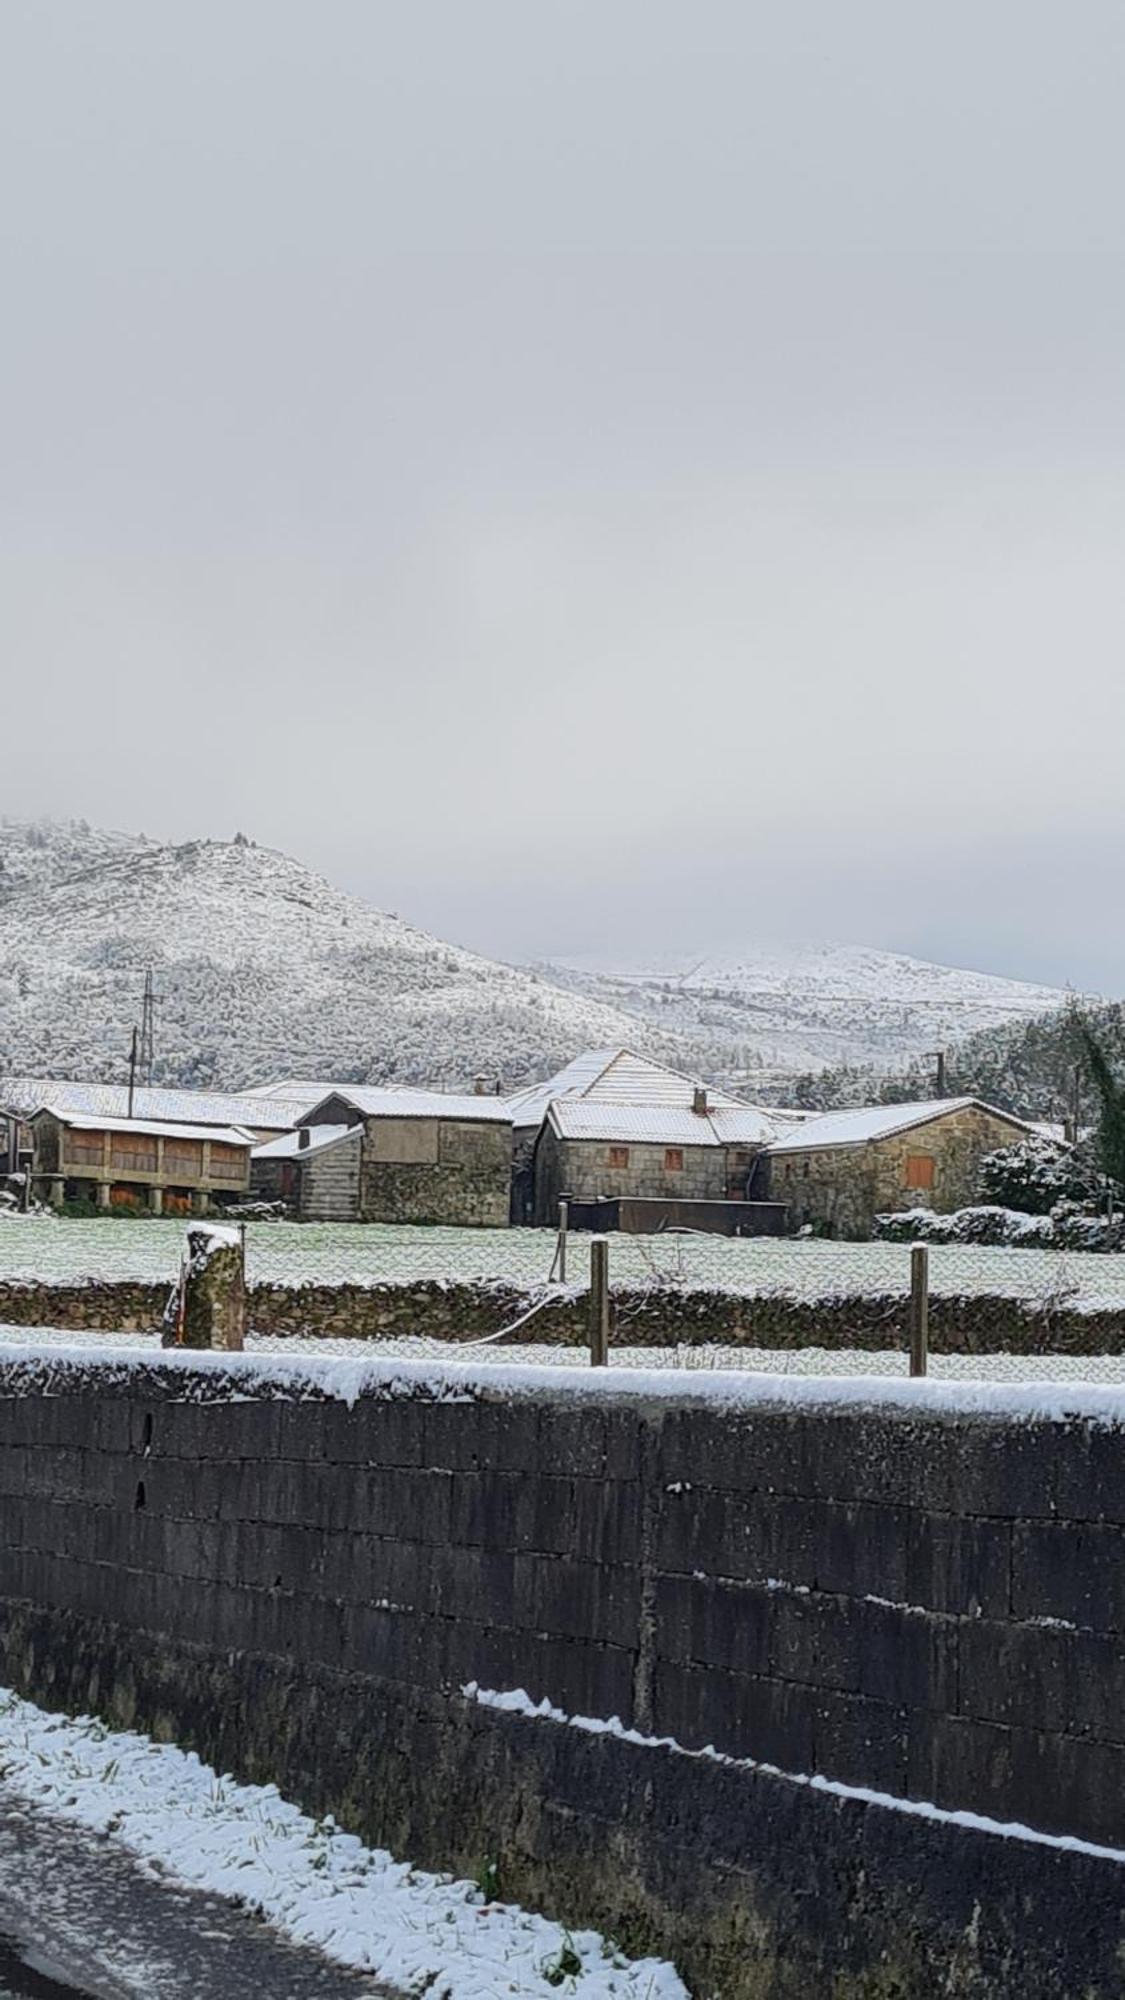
[510, 1048, 777, 1224]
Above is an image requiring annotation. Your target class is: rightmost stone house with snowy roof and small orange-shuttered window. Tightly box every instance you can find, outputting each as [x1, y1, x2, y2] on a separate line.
[755, 1098, 1033, 1238]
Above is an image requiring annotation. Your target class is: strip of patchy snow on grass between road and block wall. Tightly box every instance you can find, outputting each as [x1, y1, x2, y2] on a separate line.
[0, 1690, 687, 2000]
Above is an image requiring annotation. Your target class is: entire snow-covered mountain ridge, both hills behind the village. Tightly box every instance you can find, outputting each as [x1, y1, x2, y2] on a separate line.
[0, 820, 1065, 1098]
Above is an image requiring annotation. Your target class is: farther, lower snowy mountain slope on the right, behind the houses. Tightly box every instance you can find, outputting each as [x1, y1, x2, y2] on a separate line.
[538, 944, 1067, 1094]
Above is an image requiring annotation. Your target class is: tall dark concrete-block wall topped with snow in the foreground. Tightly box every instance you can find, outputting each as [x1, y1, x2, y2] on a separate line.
[0, 1348, 1125, 2000]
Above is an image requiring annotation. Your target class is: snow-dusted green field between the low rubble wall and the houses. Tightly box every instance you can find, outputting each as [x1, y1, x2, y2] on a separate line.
[0, 1216, 1125, 1312]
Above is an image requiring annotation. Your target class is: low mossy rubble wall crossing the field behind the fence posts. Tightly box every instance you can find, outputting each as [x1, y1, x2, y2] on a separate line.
[0, 1278, 1125, 1354]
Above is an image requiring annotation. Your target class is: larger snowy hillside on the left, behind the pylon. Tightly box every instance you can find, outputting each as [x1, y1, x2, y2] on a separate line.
[0, 820, 671, 1088]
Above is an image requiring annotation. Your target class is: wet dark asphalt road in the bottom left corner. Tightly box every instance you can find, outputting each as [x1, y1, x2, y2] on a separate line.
[0, 1788, 394, 2000]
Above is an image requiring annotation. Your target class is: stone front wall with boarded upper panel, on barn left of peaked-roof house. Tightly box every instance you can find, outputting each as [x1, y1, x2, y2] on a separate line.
[360, 1118, 512, 1228]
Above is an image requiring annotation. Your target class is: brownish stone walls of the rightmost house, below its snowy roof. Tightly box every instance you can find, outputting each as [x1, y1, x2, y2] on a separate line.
[757, 1106, 1019, 1238]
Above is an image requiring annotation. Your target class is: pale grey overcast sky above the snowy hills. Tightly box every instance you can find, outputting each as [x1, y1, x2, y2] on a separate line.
[0, 0, 1125, 992]
